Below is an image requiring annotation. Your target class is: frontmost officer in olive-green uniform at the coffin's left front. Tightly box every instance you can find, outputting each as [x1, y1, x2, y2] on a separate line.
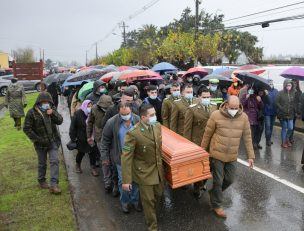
[121, 104, 164, 230]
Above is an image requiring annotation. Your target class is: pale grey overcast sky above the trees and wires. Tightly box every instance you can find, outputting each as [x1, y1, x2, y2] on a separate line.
[0, 0, 304, 64]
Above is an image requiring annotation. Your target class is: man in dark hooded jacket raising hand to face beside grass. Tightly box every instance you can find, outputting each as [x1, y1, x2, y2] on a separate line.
[23, 92, 63, 194]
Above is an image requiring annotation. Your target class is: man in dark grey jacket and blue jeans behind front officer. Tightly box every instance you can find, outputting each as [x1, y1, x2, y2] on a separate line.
[100, 102, 139, 213]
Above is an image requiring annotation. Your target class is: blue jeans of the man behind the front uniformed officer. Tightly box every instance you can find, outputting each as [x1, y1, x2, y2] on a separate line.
[116, 164, 139, 206]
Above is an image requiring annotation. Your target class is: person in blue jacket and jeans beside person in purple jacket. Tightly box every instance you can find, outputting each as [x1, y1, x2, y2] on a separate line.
[264, 80, 278, 146]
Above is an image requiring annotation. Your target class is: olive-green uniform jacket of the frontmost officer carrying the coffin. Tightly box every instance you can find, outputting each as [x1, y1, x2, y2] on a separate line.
[121, 122, 164, 185]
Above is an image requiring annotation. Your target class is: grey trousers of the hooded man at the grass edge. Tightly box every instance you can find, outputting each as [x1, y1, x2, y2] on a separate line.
[35, 142, 59, 186]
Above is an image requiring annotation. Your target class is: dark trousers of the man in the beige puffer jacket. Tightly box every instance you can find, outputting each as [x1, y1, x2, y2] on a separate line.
[210, 158, 237, 209]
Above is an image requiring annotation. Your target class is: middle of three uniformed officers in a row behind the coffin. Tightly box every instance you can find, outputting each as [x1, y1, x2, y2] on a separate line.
[170, 84, 197, 136]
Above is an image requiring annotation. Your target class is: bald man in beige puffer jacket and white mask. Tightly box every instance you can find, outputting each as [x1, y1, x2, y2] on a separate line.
[201, 96, 254, 218]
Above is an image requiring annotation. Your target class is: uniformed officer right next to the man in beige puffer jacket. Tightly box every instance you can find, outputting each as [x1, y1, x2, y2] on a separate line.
[184, 86, 217, 198]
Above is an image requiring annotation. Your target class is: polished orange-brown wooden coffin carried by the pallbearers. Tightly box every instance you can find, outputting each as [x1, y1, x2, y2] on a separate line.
[162, 126, 212, 189]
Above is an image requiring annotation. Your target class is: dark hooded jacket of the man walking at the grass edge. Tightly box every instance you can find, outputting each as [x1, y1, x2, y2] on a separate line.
[23, 92, 63, 148]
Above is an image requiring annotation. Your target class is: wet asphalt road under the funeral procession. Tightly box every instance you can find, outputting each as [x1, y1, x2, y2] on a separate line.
[60, 98, 304, 231]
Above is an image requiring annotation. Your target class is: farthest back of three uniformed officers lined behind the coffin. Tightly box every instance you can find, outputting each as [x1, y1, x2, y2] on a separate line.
[161, 82, 180, 128]
